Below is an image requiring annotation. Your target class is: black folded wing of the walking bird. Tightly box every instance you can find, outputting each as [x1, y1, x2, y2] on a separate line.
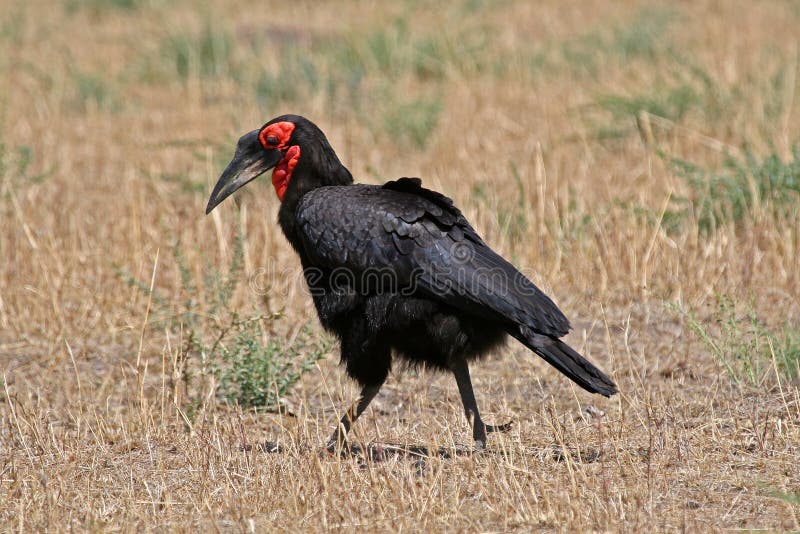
[296, 178, 570, 337]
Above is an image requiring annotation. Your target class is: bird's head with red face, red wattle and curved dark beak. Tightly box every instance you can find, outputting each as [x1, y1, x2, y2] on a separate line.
[206, 115, 352, 213]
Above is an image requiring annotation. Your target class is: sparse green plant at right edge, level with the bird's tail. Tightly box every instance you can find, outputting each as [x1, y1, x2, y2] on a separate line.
[673, 295, 800, 386]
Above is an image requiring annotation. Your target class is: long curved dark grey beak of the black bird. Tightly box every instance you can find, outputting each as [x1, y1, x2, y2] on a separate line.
[206, 130, 283, 215]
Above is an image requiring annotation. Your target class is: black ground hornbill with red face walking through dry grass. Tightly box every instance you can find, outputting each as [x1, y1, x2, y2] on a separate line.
[206, 115, 617, 450]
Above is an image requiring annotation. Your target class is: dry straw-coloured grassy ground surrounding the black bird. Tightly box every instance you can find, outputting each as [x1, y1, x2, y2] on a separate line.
[0, 0, 800, 532]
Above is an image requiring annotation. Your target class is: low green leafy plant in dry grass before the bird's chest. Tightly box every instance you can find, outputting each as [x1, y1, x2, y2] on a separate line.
[119, 224, 331, 413]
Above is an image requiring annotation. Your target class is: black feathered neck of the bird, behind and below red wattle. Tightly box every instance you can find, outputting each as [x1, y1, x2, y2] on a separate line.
[278, 150, 353, 252]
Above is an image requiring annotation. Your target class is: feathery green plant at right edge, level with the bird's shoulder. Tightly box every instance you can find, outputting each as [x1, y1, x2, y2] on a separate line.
[665, 145, 800, 232]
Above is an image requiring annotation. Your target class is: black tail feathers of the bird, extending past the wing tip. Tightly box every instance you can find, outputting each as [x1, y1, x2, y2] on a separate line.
[510, 326, 617, 397]
